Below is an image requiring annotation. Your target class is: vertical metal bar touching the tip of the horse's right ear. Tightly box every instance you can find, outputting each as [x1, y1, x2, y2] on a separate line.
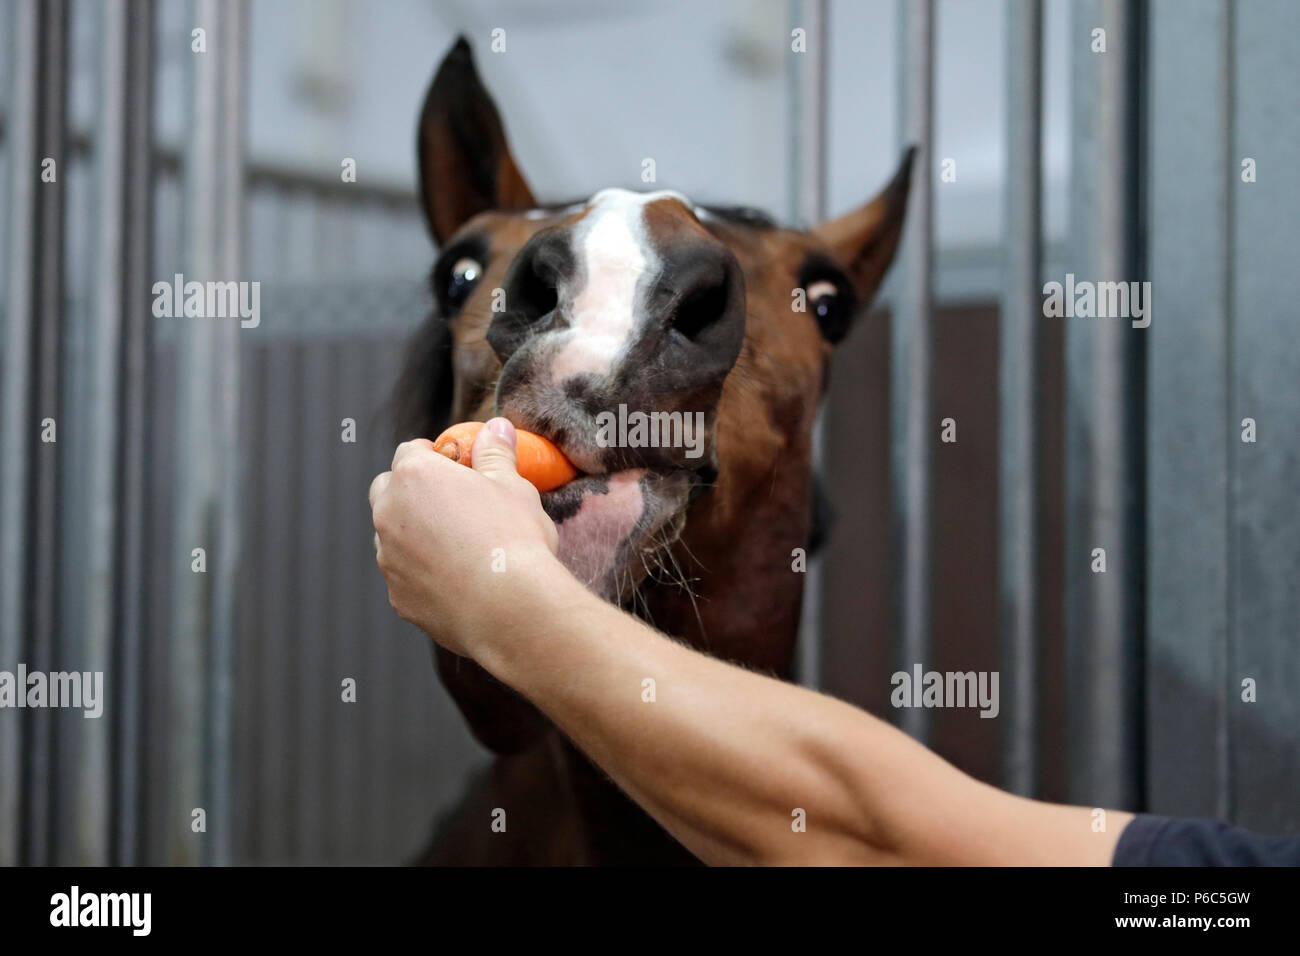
[889, 0, 936, 740]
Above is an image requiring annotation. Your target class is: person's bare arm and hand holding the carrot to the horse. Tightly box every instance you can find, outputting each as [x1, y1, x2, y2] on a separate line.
[372, 418, 1130, 865]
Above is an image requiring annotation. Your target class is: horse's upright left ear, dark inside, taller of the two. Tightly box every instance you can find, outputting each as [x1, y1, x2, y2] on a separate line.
[416, 36, 537, 245]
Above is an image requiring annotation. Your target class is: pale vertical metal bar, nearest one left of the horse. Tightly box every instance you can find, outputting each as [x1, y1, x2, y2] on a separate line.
[168, 0, 246, 865]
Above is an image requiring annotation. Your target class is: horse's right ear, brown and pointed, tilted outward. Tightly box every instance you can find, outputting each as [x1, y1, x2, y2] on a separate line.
[813, 146, 917, 308]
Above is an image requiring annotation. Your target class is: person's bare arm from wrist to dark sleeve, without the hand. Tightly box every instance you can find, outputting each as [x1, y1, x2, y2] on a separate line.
[476, 556, 1118, 864]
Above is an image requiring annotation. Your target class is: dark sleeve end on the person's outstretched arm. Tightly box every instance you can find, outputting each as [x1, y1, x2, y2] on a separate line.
[1112, 814, 1300, 866]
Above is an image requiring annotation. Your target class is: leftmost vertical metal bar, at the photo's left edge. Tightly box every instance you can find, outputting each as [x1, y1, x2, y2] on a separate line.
[0, 0, 42, 866]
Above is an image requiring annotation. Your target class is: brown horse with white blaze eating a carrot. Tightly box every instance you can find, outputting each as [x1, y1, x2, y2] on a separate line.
[395, 39, 911, 864]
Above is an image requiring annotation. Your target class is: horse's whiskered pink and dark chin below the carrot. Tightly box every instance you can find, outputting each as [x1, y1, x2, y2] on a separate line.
[542, 468, 692, 604]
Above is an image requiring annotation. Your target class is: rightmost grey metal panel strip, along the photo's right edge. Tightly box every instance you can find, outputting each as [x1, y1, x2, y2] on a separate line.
[1227, 0, 1300, 832]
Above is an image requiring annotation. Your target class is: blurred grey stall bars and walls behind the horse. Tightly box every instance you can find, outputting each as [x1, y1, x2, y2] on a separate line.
[0, 0, 1300, 864]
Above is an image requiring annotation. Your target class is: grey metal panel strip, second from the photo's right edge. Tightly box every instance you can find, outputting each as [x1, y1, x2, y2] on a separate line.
[1145, 0, 1240, 819]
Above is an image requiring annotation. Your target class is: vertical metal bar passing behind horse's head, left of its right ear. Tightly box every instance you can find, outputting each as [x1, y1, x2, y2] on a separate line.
[790, 0, 831, 687]
